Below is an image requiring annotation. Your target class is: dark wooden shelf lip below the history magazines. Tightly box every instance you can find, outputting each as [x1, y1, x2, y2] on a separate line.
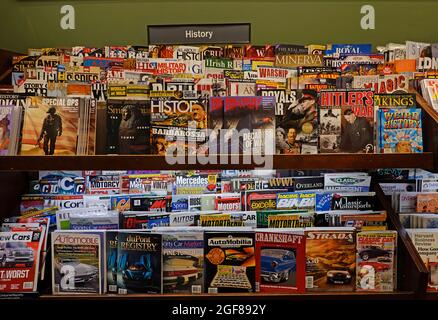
[0, 152, 434, 171]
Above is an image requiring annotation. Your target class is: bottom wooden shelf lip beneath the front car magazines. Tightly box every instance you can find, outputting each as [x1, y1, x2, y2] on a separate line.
[39, 291, 418, 301]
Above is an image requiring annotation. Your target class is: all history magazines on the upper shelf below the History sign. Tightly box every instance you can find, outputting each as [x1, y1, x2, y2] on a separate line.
[0, 41, 438, 155]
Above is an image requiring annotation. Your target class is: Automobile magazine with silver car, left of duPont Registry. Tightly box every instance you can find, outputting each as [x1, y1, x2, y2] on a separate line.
[52, 231, 104, 294]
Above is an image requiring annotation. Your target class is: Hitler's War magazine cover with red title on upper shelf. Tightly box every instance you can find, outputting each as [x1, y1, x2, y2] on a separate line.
[319, 90, 374, 153]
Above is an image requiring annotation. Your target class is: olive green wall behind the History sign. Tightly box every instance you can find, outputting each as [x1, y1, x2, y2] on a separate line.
[0, 0, 438, 52]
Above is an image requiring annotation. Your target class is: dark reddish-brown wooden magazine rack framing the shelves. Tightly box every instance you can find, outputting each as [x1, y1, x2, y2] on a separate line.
[0, 77, 438, 301]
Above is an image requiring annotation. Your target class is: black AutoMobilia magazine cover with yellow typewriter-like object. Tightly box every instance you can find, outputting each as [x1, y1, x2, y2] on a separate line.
[204, 231, 256, 293]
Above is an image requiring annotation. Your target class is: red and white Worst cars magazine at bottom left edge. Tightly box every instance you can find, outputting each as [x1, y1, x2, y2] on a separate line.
[0, 229, 44, 293]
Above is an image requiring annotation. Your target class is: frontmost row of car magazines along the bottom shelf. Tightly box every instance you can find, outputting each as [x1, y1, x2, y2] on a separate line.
[0, 218, 397, 295]
